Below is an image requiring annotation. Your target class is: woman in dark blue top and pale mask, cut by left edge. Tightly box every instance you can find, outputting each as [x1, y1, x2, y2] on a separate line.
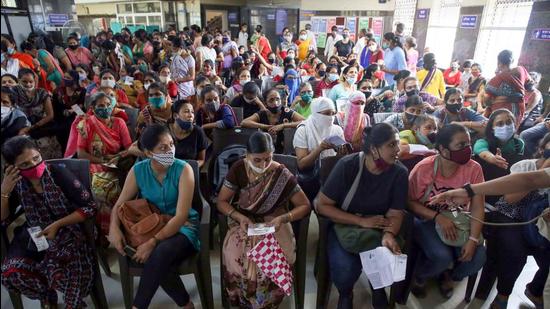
[0, 86, 31, 145]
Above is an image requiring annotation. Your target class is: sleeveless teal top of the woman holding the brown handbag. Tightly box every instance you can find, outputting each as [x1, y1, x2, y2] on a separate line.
[134, 159, 200, 251]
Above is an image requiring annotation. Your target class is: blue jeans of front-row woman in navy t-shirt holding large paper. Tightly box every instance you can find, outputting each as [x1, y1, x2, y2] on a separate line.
[327, 226, 389, 308]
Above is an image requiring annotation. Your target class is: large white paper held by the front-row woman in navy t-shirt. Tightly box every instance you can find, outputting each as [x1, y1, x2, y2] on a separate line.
[359, 247, 407, 289]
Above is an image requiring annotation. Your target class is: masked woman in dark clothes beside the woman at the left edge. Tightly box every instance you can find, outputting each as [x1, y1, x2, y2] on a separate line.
[13, 69, 61, 160]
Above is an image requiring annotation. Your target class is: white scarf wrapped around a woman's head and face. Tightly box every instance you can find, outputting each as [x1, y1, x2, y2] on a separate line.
[303, 97, 335, 155]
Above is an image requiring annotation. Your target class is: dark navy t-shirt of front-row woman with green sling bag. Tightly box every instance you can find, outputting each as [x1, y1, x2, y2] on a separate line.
[321, 154, 409, 215]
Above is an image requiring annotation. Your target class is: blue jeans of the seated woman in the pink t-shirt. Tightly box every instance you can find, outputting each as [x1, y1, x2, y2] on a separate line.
[414, 218, 486, 281]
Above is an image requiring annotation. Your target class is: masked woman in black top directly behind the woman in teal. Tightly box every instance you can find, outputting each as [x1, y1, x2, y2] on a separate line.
[169, 100, 208, 167]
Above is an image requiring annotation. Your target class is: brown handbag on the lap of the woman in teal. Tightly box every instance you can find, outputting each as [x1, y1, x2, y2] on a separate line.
[117, 199, 172, 248]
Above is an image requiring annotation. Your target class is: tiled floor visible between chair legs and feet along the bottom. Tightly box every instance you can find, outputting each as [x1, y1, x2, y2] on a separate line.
[1, 216, 537, 309]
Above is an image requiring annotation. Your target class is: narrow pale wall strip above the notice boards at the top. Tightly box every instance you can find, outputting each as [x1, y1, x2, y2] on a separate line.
[301, 0, 395, 11]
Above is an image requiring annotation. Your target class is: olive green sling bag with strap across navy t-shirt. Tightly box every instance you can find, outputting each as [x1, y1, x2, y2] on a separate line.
[334, 151, 404, 254]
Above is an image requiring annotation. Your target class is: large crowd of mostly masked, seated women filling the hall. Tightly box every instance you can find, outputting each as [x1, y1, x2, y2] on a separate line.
[1, 26, 550, 309]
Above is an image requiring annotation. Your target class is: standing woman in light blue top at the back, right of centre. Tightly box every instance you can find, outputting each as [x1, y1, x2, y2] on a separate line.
[380, 32, 407, 85]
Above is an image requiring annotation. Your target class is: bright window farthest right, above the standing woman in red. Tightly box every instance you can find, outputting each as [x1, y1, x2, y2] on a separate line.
[474, 0, 533, 78]
